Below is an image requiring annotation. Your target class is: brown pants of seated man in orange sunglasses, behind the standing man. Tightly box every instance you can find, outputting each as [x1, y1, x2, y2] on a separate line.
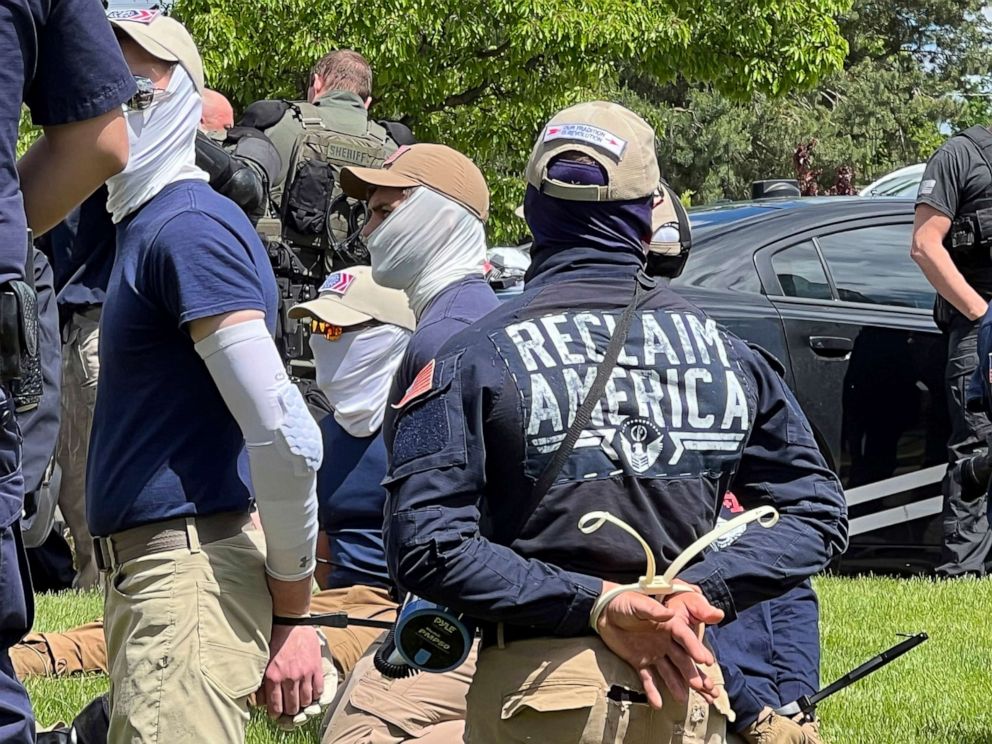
[10, 586, 396, 679]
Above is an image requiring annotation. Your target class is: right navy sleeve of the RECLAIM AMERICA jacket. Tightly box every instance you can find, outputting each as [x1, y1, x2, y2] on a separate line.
[680, 341, 847, 621]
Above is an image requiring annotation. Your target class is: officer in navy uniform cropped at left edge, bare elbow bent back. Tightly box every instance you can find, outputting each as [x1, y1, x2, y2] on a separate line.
[0, 0, 134, 744]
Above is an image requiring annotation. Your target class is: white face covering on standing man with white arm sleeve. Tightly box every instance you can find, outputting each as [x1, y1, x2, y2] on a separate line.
[107, 65, 209, 223]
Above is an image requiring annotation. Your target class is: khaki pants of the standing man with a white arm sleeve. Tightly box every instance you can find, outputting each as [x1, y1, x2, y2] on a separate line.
[104, 527, 272, 744]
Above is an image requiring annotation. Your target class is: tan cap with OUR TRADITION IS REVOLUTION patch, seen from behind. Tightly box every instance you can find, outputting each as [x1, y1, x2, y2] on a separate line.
[527, 101, 661, 202]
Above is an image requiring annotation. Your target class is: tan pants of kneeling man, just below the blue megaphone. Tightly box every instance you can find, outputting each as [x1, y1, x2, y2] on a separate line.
[320, 644, 478, 744]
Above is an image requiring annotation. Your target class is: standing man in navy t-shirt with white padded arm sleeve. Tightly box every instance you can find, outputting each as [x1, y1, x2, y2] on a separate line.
[87, 11, 323, 742]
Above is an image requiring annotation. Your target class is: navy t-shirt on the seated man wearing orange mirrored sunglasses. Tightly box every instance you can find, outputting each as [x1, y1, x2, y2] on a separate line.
[317, 414, 393, 589]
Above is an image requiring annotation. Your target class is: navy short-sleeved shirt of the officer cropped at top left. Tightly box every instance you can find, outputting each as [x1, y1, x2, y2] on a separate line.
[0, 0, 134, 283]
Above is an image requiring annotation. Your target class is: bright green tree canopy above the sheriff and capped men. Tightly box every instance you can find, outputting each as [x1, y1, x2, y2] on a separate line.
[173, 0, 849, 240]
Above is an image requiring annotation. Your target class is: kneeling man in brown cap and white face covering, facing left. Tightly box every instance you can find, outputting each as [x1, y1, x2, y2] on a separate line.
[321, 144, 498, 744]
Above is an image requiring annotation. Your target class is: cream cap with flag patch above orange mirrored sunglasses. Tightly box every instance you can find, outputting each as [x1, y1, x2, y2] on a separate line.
[289, 266, 417, 331]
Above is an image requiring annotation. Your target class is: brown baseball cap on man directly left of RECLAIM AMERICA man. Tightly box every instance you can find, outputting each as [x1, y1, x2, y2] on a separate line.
[341, 142, 489, 222]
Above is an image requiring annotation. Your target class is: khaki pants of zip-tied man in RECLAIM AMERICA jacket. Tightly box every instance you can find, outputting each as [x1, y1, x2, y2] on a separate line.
[465, 636, 730, 744]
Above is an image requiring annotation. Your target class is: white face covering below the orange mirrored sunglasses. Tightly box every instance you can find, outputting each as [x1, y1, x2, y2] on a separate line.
[310, 324, 411, 437]
